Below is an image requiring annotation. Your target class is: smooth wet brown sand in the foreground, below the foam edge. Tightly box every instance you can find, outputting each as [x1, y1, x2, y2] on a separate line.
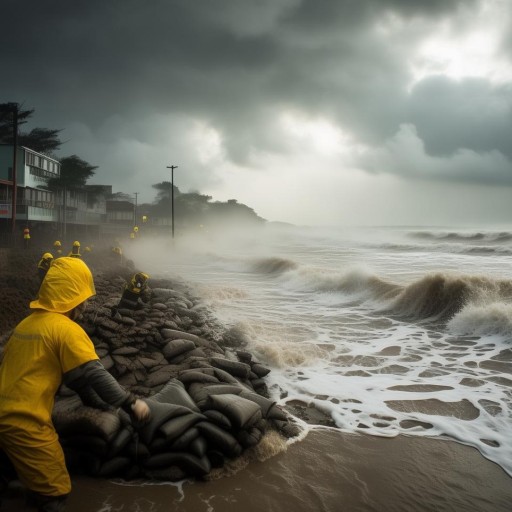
[1, 429, 512, 512]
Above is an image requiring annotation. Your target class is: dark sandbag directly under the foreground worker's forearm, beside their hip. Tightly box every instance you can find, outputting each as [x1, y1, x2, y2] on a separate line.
[52, 406, 121, 442]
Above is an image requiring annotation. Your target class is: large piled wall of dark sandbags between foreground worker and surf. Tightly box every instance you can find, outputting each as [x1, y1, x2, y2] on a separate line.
[53, 270, 293, 481]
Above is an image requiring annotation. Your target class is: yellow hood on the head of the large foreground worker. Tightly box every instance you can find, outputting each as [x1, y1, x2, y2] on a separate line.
[30, 257, 96, 313]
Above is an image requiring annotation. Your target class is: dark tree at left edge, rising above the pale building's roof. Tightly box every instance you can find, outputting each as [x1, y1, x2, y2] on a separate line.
[0, 102, 62, 154]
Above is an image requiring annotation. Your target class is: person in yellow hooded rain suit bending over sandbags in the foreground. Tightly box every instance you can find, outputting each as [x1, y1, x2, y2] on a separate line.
[0, 257, 150, 512]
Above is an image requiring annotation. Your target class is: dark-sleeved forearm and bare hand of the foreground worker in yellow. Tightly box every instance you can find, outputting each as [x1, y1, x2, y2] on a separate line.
[63, 360, 149, 420]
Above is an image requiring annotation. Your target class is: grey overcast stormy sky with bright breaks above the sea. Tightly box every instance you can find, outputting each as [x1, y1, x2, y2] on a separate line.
[0, 0, 512, 225]
